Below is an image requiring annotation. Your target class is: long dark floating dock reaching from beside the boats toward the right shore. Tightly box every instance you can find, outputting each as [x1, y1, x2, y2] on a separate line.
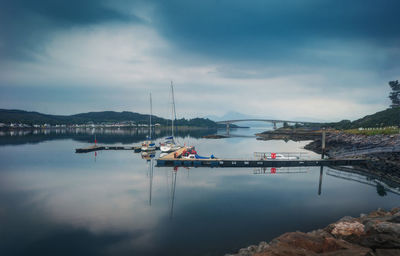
[157, 158, 366, 168]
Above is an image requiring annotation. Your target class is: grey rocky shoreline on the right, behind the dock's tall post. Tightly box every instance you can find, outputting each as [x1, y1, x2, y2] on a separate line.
[256, 129, 400, 173]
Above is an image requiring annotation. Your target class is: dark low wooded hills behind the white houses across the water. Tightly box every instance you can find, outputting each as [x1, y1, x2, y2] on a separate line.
[0, 109, 222, 128]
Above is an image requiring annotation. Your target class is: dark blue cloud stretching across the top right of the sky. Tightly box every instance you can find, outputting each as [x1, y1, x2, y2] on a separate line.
[151, 0, 400, 62]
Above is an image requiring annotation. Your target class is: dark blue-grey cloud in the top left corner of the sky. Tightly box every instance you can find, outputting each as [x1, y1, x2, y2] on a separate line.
[0, 0, 142, 59]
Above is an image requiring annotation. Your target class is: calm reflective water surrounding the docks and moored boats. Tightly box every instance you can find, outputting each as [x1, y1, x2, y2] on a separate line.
[0, 129, 400, 255]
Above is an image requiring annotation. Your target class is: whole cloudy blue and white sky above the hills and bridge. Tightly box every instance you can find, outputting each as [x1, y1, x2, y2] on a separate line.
[0, 0, 400, 121]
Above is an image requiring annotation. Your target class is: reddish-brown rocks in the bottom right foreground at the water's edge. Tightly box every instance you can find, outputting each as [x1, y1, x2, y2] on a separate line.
[226, 208, 400, 256]
